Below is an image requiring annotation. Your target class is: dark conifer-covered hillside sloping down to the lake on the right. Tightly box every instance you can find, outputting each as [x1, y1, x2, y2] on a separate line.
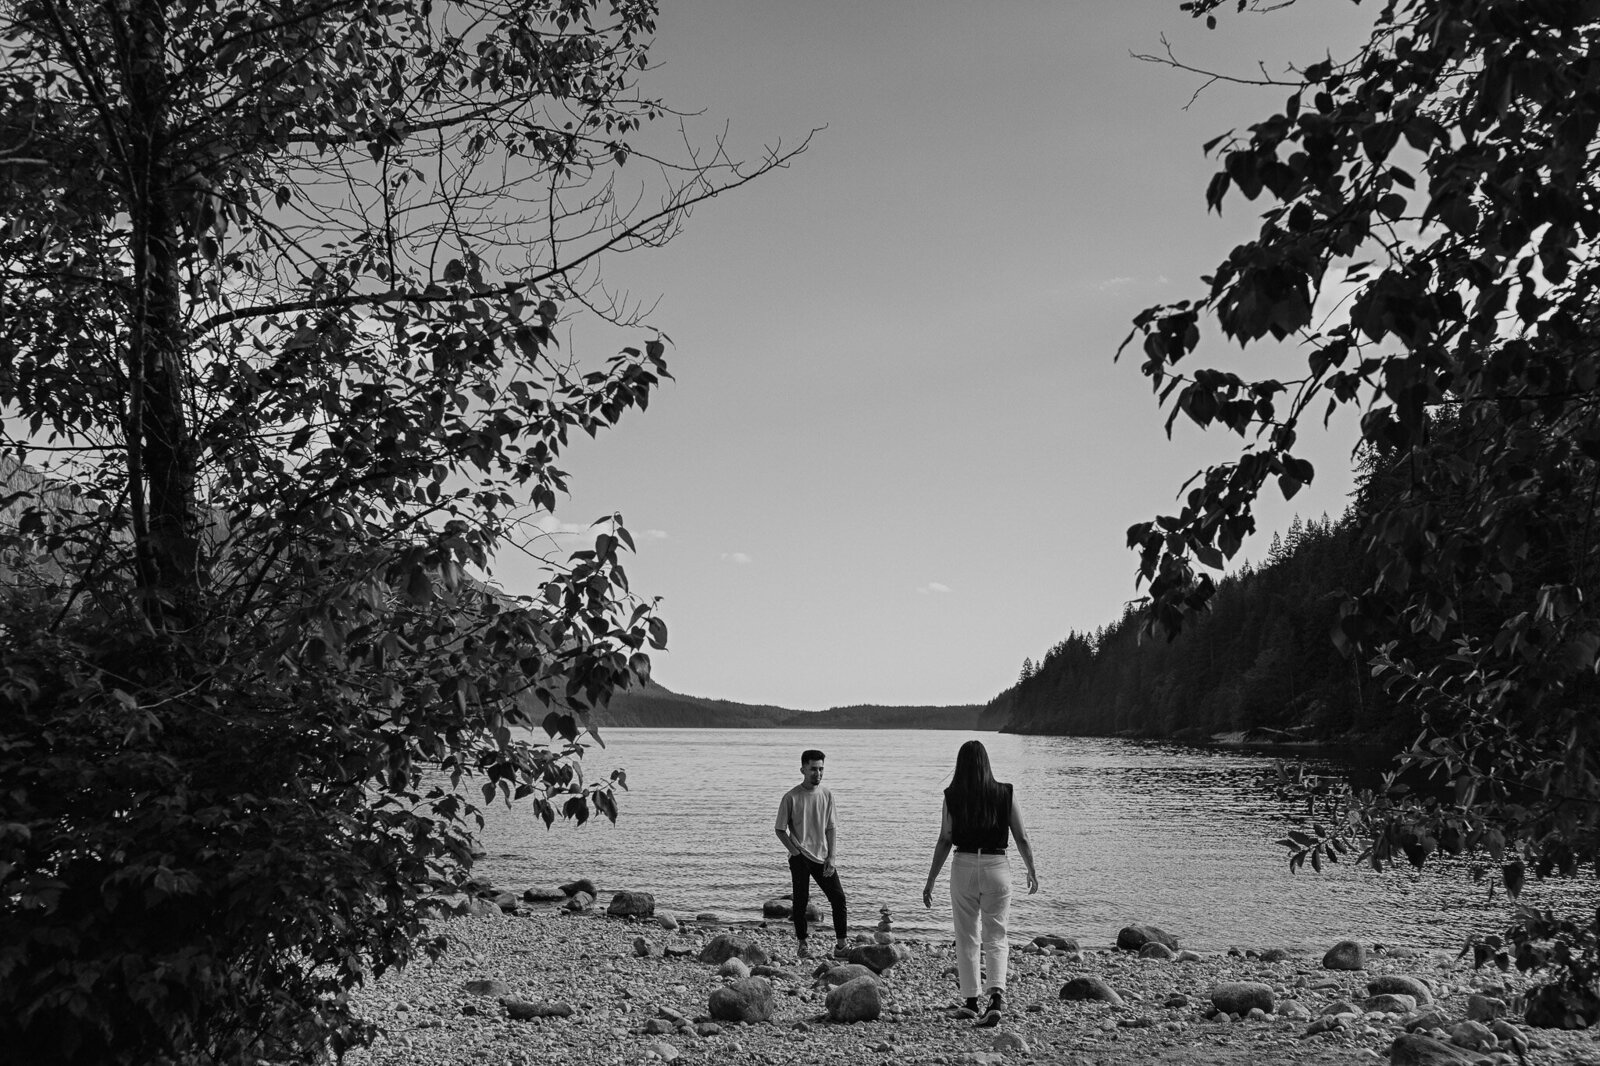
[982, 514, 1414, 739]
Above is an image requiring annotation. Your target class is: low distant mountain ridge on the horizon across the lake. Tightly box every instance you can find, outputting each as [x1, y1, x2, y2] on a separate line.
[592, 682, 997, 730]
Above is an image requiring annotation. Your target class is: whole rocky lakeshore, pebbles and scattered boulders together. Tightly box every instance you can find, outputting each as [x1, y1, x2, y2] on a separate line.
[346, 885, 1600, 1066]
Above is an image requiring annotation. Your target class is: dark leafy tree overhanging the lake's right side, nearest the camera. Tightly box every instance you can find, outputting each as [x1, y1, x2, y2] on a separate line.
[1125, 0, 1600, 1023]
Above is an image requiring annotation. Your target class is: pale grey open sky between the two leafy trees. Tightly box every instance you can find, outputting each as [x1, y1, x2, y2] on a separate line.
[494, 0, 1373, 709]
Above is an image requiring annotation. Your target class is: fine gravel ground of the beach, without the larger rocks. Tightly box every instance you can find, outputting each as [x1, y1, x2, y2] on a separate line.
[346, 904, 1600, 1066]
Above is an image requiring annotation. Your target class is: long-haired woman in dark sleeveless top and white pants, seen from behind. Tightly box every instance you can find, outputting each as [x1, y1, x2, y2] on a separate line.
[922, 741, 1038, 1026]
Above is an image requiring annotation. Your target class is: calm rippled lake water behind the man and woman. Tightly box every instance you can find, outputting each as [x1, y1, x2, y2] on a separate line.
[478, 728, 1595, 949]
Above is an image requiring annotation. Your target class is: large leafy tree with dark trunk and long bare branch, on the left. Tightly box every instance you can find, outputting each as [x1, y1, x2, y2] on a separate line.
[0, 0, 803, 1061]
